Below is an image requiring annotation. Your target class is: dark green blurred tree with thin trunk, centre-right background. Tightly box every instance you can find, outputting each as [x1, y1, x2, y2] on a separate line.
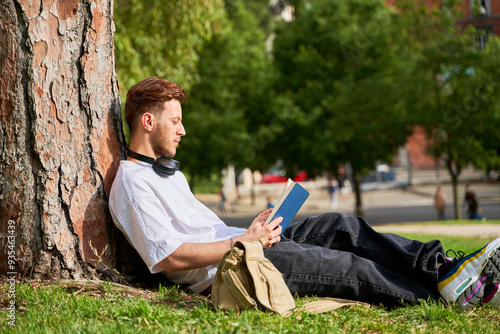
[273, 0, 413, 215]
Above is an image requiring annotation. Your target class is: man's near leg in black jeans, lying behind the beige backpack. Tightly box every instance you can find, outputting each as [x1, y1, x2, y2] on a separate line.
[265, 240, 440, 307]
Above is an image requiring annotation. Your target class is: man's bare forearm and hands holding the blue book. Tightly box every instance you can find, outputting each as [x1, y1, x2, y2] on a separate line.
[160, 209, 283, 272]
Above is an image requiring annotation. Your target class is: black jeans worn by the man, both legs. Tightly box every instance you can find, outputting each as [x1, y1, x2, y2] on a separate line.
[265, 213, 443, 307]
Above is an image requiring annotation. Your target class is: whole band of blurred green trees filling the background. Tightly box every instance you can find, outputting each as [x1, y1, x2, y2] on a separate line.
[115, 0, 500, 215]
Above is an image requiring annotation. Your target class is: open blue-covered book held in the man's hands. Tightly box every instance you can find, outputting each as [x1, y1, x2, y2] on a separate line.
[264, 179, 309, 231]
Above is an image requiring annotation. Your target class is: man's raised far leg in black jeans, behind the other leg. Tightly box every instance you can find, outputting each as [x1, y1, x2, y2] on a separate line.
[284, 212, 444, 289]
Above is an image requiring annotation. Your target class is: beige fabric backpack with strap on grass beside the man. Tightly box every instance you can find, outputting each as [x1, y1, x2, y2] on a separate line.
[211, 241, 368, 316]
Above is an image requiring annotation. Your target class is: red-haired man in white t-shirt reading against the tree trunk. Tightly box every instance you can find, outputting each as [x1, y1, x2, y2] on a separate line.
[110, 78, 500, 309]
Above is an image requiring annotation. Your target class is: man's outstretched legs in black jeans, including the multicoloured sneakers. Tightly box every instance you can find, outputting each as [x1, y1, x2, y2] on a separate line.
[266, 213, 500, 309]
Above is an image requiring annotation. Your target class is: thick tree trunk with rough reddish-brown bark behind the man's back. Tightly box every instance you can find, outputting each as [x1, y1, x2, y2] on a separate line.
[0, 0, 129, 278]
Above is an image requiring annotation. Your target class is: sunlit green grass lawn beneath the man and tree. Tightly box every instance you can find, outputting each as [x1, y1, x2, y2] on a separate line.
[0, 228, 500, 334]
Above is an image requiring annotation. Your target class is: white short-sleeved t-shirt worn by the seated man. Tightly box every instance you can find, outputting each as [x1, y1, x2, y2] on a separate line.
[109, 160, 246, 292]
